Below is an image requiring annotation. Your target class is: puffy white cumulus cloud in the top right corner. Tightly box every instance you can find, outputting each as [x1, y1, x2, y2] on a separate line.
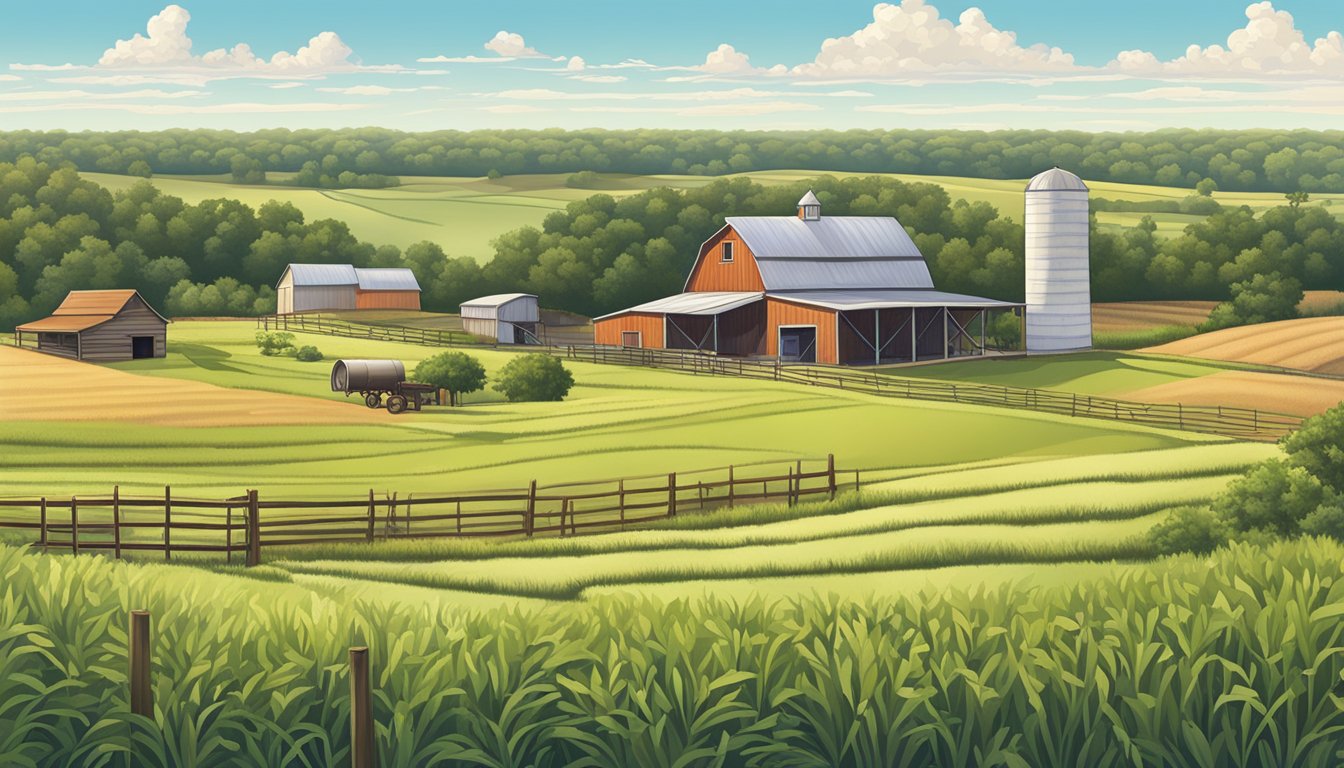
[1109, 0, 1344, 77]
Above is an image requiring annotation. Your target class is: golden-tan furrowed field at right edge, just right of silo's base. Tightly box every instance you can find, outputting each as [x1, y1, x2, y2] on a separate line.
[1144, 317, 1344, 375]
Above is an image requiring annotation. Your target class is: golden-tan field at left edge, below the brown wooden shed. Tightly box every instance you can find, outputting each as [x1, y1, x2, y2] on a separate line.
[0, 347, 388, 426]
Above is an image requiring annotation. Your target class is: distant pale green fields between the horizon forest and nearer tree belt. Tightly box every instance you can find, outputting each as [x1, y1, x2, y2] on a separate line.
[83, 171, 1344, 261]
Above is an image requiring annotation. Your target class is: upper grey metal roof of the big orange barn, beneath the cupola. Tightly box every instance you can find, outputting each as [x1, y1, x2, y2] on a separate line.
[724, 217, 933, 292]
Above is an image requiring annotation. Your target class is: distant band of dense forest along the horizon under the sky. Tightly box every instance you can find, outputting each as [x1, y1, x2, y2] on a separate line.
[0, 128, 1344, 192]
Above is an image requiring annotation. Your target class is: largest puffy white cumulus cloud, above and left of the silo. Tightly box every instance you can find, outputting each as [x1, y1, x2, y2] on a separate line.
[792, 0, 1078, 78]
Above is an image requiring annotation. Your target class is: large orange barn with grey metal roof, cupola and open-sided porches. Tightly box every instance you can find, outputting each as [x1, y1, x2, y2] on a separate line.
[594, 191, 1020, 364]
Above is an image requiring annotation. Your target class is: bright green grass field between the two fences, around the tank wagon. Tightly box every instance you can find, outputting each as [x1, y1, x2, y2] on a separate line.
[0, 321, 1211, 495]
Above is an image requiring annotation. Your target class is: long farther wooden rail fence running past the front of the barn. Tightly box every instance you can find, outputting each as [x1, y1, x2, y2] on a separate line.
[258, 315, 1302, 440]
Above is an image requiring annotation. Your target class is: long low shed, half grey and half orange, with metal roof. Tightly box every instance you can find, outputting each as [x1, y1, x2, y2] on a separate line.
[276, 264, 419, 315]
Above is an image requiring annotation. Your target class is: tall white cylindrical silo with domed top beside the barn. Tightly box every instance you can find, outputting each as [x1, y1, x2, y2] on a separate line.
[1023, 168, 1091, 352]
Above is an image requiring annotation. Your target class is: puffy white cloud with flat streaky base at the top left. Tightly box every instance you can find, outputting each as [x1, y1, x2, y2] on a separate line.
[12, 5, 402, 85]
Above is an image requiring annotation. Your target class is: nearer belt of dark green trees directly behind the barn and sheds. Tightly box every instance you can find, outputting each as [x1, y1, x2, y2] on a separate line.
[0, 157, 1344, 328]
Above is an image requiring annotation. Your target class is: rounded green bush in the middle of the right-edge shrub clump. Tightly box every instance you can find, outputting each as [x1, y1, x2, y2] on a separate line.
[1214, 460, 1335, 537]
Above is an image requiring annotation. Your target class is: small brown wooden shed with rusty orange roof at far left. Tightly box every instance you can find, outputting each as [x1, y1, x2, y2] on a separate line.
[13, 289, 168, 362]
